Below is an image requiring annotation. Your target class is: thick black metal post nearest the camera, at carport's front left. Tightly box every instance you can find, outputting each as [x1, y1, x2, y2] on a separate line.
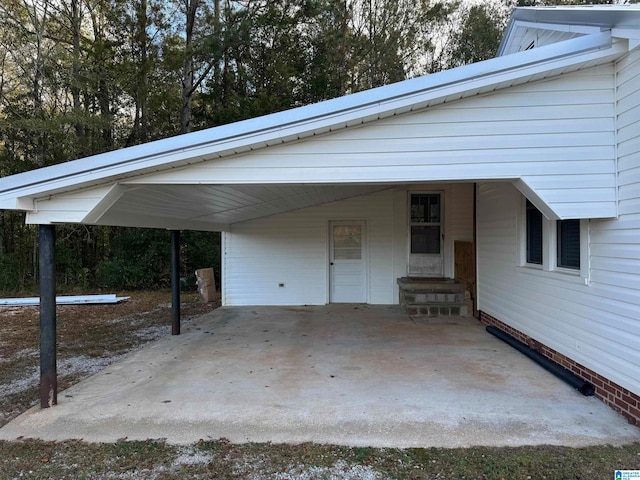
[38, 225, 58, 408]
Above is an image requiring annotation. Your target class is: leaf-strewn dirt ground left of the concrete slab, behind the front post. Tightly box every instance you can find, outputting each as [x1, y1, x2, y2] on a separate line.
[0, 291, 220, 427]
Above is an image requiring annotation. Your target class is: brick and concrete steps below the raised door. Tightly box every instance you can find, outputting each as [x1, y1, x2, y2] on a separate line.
[397, 277, 473, 317]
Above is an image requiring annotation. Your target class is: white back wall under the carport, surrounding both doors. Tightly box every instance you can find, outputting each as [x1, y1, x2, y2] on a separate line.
[222, 184, 473, 305]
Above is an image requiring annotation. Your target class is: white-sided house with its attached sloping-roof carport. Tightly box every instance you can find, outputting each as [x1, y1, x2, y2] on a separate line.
[0, 6, 640, 424]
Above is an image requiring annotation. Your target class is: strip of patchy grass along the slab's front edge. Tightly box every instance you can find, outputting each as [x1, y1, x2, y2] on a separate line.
[0, 440, 640, 480]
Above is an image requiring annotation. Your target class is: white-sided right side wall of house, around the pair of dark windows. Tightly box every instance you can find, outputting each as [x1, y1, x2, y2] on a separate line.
[478, 49, 640, 394]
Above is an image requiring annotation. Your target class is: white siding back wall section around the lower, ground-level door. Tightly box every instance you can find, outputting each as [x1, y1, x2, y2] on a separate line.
[223, 191, 396, 305]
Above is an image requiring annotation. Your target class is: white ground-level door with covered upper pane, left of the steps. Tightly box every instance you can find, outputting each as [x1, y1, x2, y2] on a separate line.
[329, 220, 367, 303]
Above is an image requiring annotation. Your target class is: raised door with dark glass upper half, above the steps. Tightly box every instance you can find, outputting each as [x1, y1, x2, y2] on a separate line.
[409, 193, 444, 277]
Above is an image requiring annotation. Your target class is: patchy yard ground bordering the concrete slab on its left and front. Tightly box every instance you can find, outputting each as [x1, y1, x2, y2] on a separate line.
[0, 292, 640, 480]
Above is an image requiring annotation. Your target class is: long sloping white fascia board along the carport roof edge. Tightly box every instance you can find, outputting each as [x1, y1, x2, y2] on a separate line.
[0, 32, 626, 206]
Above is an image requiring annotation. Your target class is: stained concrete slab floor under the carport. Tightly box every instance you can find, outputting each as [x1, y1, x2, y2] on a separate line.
[0, 305, 640, 447]
